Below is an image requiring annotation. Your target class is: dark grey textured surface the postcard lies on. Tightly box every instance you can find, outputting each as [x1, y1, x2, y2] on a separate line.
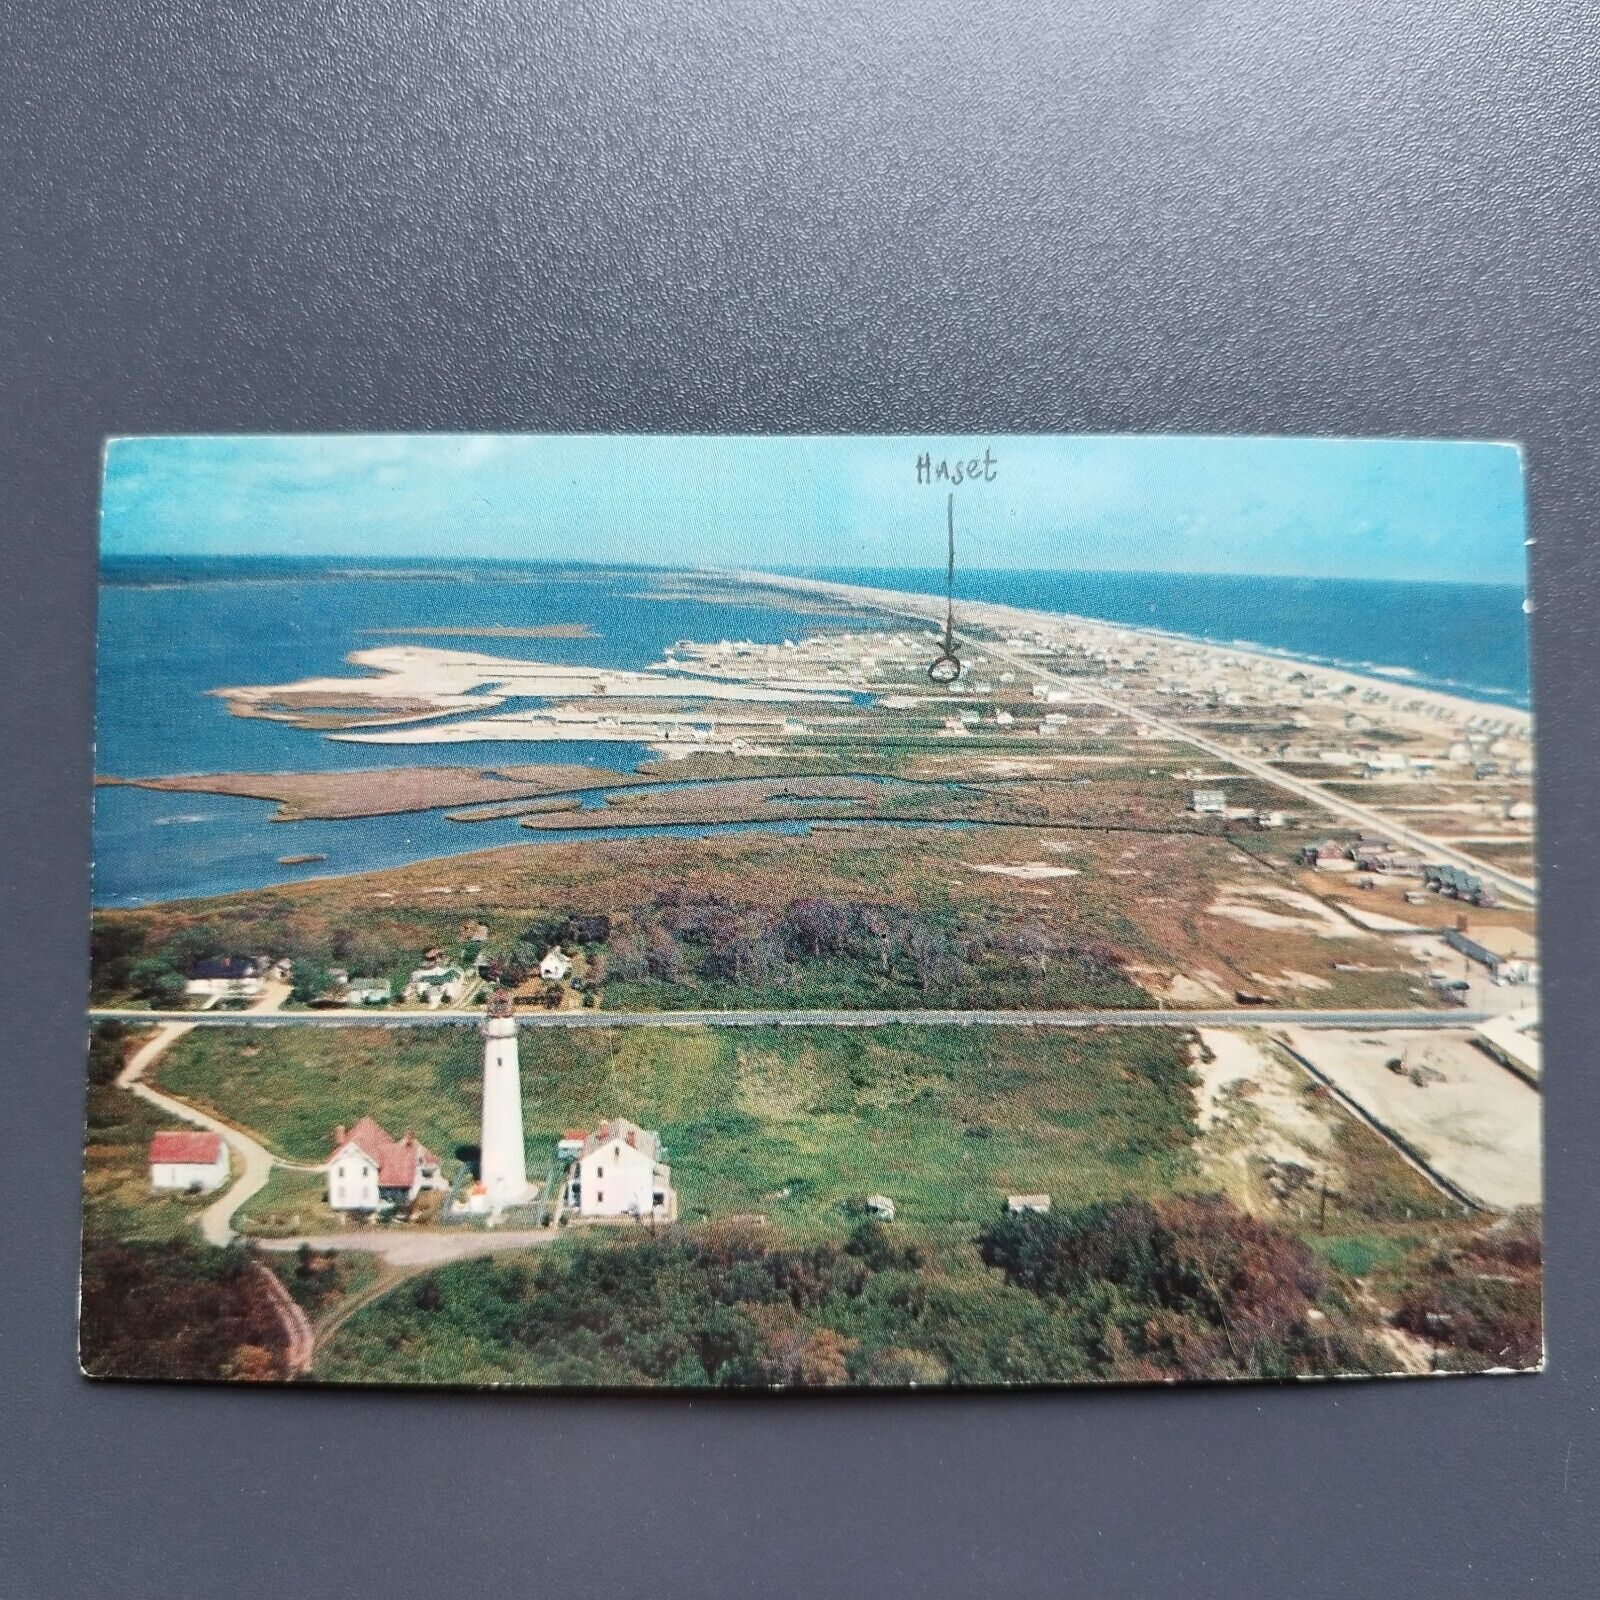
[0, 0, 1600, 1600]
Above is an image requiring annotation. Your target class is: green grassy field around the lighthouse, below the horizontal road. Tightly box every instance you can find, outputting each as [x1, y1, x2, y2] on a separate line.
[160, 1027, 1197, 1232]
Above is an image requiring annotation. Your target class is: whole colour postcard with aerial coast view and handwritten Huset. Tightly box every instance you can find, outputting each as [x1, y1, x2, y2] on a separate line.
[78, 434, 1544, 1392]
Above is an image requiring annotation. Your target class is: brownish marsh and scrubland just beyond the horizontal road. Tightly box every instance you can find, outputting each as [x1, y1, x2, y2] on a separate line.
[93, 812, 1432, 1010]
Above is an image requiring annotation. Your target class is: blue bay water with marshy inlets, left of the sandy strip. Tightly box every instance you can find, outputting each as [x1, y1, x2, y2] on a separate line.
[94, 560, 876, 906]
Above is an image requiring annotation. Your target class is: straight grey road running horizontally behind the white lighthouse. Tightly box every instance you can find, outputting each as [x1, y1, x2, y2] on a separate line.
[90, 1006, 1493, 1030]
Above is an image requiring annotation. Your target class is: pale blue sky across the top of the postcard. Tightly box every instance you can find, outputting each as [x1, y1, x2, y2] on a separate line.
[101, 434, 1525, 584]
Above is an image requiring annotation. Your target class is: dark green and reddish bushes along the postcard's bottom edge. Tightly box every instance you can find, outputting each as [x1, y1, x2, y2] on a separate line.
[318, 1200, 1381, 1387]
